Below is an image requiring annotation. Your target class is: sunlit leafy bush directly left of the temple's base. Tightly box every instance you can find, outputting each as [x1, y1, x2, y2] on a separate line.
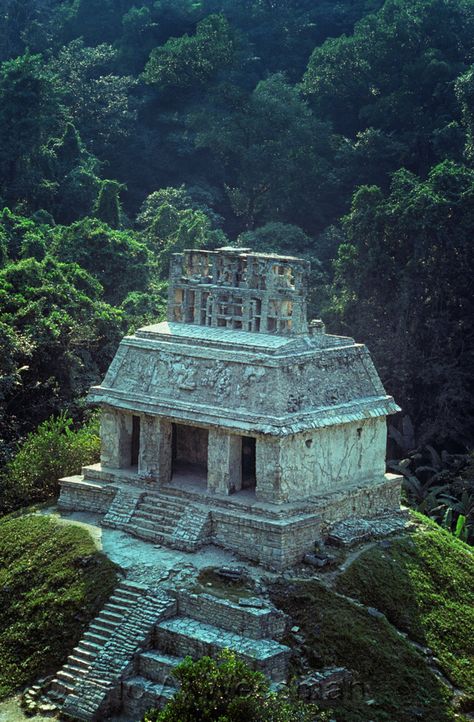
[0, 414, 100, 514]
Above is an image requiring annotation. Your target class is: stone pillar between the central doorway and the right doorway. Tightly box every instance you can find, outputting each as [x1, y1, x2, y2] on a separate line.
[207, 429, 242, 495]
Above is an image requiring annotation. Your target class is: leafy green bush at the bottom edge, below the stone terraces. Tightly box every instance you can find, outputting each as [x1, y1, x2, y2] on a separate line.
[144, 651, 323, 722]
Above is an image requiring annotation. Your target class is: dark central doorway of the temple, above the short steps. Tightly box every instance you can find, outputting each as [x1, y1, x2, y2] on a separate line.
[171, 424, 209, 481]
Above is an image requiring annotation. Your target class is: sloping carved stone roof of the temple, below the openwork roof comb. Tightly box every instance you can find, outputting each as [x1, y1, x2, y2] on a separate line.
[89, 322, 399, 436]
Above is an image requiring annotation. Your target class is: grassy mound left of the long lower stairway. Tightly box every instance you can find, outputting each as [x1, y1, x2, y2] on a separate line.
[0, 515, 117, 699]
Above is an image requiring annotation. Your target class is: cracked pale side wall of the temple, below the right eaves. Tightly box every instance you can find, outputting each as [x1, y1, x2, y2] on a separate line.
[280, 418, 386, 501]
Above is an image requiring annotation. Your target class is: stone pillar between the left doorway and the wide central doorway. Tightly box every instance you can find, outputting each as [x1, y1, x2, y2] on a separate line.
[138, 414, 172, 486]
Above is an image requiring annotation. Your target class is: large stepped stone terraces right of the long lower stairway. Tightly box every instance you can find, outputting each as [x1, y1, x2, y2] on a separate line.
[122, 592, 291, 720]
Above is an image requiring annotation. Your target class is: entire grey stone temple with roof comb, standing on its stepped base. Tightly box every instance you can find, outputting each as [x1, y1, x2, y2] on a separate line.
[60, 248, 400, 569]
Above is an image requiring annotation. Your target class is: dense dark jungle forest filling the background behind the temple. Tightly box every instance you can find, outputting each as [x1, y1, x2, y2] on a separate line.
[0, 0, 474, 537]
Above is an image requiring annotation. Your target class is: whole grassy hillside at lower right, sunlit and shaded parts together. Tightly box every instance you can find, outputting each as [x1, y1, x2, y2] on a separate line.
[272, 512, 474, 722]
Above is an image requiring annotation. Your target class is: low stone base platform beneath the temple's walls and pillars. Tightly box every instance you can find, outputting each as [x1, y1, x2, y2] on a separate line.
[58, 470, 402, 570]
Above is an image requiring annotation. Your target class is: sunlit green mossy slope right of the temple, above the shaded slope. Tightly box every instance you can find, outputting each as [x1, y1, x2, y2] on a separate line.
[337, 515, 474, 695]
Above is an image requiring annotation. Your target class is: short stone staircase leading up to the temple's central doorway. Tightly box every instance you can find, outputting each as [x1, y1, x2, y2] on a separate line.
[121, 493, 210, 552]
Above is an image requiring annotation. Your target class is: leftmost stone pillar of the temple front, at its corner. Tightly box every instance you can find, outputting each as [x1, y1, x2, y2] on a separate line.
[100, 409, 132, 469]
